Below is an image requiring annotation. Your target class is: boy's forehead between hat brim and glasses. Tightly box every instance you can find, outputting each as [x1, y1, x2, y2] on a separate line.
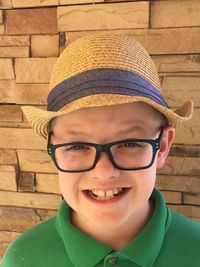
[51, 102, 163, 136]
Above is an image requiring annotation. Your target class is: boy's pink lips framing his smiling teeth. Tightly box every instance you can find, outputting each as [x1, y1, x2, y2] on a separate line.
[82, 187, 131, 205]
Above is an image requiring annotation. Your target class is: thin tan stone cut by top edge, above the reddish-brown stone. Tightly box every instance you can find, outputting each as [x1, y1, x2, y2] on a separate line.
[12, 0, 59, 8]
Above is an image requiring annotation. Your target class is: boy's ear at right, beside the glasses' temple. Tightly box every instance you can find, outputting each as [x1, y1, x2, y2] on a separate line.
[156, 126, 175, 169]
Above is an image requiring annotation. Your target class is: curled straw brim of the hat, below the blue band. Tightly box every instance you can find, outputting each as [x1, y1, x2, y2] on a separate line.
[22, 94, 193, 139]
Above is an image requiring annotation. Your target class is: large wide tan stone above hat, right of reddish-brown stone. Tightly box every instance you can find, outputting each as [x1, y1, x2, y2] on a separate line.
[58, 2, 149, 31]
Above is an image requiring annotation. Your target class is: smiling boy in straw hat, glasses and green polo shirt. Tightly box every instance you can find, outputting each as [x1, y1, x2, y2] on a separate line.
[1, 34, 200, 267]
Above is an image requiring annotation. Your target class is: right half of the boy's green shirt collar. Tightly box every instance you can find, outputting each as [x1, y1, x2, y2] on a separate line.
[118, 189, 171, 267]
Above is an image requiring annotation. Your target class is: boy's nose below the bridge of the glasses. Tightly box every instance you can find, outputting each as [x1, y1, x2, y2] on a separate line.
[90, 152, 121, 180]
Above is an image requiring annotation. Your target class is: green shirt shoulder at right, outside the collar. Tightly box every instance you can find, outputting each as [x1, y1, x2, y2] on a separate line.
[162, 211, 200, 267]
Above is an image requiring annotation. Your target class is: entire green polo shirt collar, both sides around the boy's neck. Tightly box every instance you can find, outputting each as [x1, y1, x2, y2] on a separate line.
[56, 189, 171, 267]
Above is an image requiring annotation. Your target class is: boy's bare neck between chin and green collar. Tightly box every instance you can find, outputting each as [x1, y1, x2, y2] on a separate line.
[71, 200, 154, 250]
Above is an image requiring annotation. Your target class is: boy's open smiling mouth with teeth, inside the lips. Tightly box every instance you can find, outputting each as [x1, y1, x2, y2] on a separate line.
[84, 187, 130, 200]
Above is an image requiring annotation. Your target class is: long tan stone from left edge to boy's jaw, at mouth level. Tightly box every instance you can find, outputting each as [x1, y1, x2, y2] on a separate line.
[0, 191, 61, 210]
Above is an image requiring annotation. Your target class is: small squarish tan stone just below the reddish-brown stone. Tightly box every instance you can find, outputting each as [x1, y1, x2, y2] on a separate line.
[31, 35, 59, 57]
